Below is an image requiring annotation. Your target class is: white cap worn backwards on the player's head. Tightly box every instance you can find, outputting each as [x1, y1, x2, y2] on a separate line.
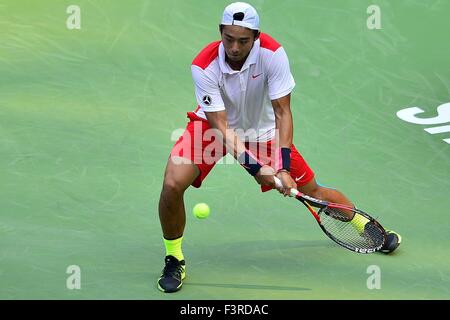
[222, 2, 259, 30]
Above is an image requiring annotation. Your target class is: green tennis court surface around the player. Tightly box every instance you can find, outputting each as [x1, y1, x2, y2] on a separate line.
[0, 0, 450, 300]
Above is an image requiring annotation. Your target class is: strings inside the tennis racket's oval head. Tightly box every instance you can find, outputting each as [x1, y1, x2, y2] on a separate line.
[319, 207, 385, 250]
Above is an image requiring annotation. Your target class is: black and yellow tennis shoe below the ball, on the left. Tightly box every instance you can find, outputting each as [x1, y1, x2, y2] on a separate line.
[158, 256, 186, 293]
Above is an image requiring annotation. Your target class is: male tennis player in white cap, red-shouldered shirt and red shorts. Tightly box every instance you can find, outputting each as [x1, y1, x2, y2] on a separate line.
[158, 2, 401, 292]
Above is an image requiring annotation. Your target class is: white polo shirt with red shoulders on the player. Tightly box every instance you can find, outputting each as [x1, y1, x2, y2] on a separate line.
[191, 33, 295, 142]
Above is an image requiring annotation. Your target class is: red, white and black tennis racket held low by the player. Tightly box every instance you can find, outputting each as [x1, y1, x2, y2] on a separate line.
[274, 177, 386, 253]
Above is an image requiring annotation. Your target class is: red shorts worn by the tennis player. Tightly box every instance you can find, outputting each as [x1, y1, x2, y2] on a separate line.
[170, 112, 314, 192]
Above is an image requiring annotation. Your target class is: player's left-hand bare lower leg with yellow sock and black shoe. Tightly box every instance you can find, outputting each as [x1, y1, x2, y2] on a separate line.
[158, 157, 200, 293]
